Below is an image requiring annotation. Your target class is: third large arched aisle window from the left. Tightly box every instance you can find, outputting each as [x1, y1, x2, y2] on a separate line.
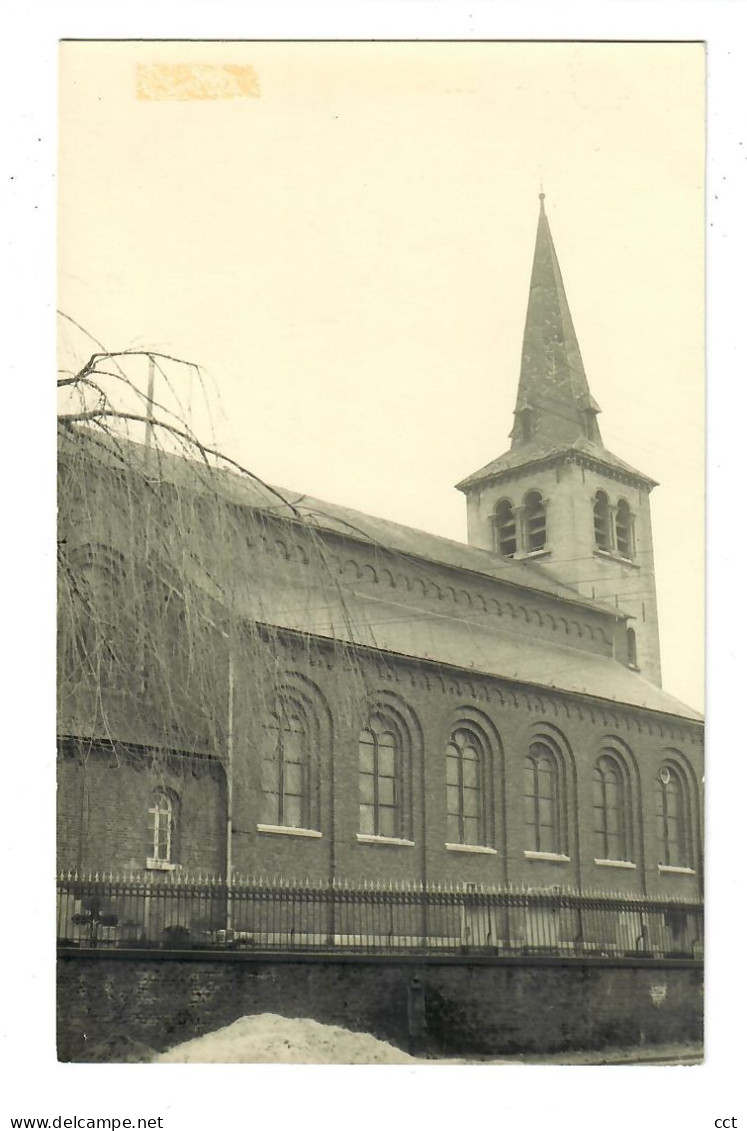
[446, 726, 488, 845]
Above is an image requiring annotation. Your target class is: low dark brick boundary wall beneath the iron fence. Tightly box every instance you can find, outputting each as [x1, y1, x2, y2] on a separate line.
[58, 952, 703, 1061]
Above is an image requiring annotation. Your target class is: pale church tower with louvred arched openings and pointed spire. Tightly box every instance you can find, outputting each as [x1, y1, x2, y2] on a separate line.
[457, 192, 661, 685]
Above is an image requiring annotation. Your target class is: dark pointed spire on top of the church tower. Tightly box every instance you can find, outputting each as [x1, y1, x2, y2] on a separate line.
[510, 192, 602, 448]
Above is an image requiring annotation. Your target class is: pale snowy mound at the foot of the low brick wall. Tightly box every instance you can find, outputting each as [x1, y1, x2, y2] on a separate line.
[154, 1013, 422, 1064]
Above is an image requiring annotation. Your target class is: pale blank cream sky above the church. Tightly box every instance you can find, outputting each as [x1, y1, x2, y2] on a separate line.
[59, 43, 704, 708]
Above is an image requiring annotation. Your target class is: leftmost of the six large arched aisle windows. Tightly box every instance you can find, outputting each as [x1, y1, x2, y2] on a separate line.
[261, 696, 311, 829]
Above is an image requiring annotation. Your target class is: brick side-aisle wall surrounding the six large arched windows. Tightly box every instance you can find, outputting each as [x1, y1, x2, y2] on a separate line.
[234, 641, 703, 898]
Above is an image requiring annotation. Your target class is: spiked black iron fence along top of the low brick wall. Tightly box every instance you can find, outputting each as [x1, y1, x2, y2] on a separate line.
[58, 872, 703, 958]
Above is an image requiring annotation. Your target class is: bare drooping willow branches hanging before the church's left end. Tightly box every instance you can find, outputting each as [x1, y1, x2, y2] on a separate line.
[58, 316, 373, 773]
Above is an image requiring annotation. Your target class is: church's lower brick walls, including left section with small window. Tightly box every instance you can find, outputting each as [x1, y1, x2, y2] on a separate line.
[59, 640, 703, 898]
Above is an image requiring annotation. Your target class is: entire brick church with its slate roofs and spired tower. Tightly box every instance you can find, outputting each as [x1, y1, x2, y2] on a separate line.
[58, 197, 703, 934]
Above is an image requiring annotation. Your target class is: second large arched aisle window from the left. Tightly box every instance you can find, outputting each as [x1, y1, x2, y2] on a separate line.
[358, 715, 404, 837]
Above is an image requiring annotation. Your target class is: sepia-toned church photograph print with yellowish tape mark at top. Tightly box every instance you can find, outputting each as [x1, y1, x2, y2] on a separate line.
[57, 35, 704, 1063]
